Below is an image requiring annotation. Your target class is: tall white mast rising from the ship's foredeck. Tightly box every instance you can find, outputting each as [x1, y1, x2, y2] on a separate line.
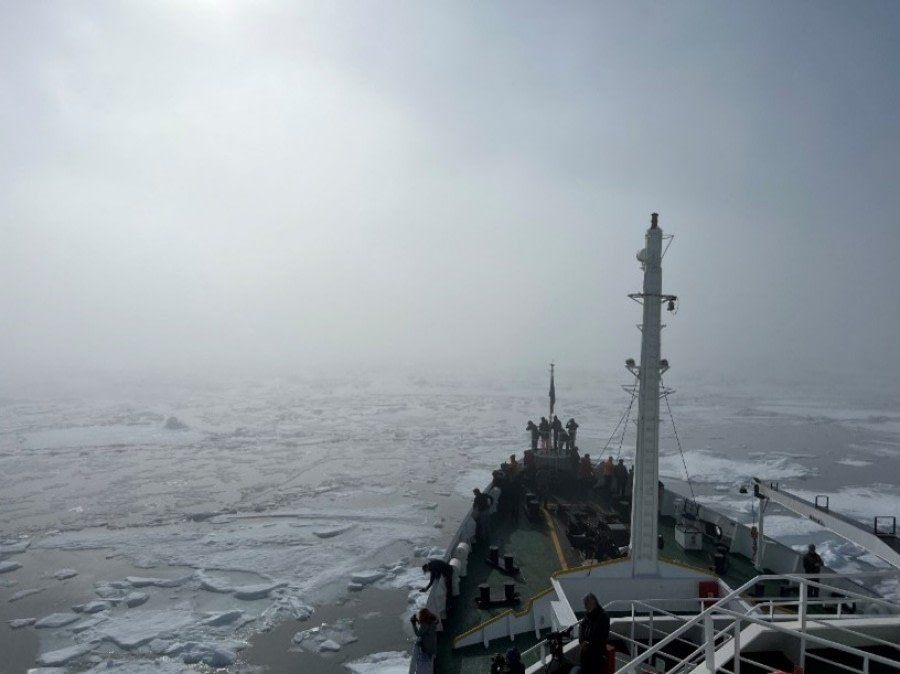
[627, 213, 675, 576]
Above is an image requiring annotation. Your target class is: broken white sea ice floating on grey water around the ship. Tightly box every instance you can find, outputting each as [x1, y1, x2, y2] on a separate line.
[0, 371, 900, 674]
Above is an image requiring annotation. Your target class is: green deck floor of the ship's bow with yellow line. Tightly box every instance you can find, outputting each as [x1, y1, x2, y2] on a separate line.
[434, 476, 758, 674]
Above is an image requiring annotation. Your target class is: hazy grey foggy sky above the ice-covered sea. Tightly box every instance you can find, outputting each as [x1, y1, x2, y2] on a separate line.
[0, 0, 900, 384]
